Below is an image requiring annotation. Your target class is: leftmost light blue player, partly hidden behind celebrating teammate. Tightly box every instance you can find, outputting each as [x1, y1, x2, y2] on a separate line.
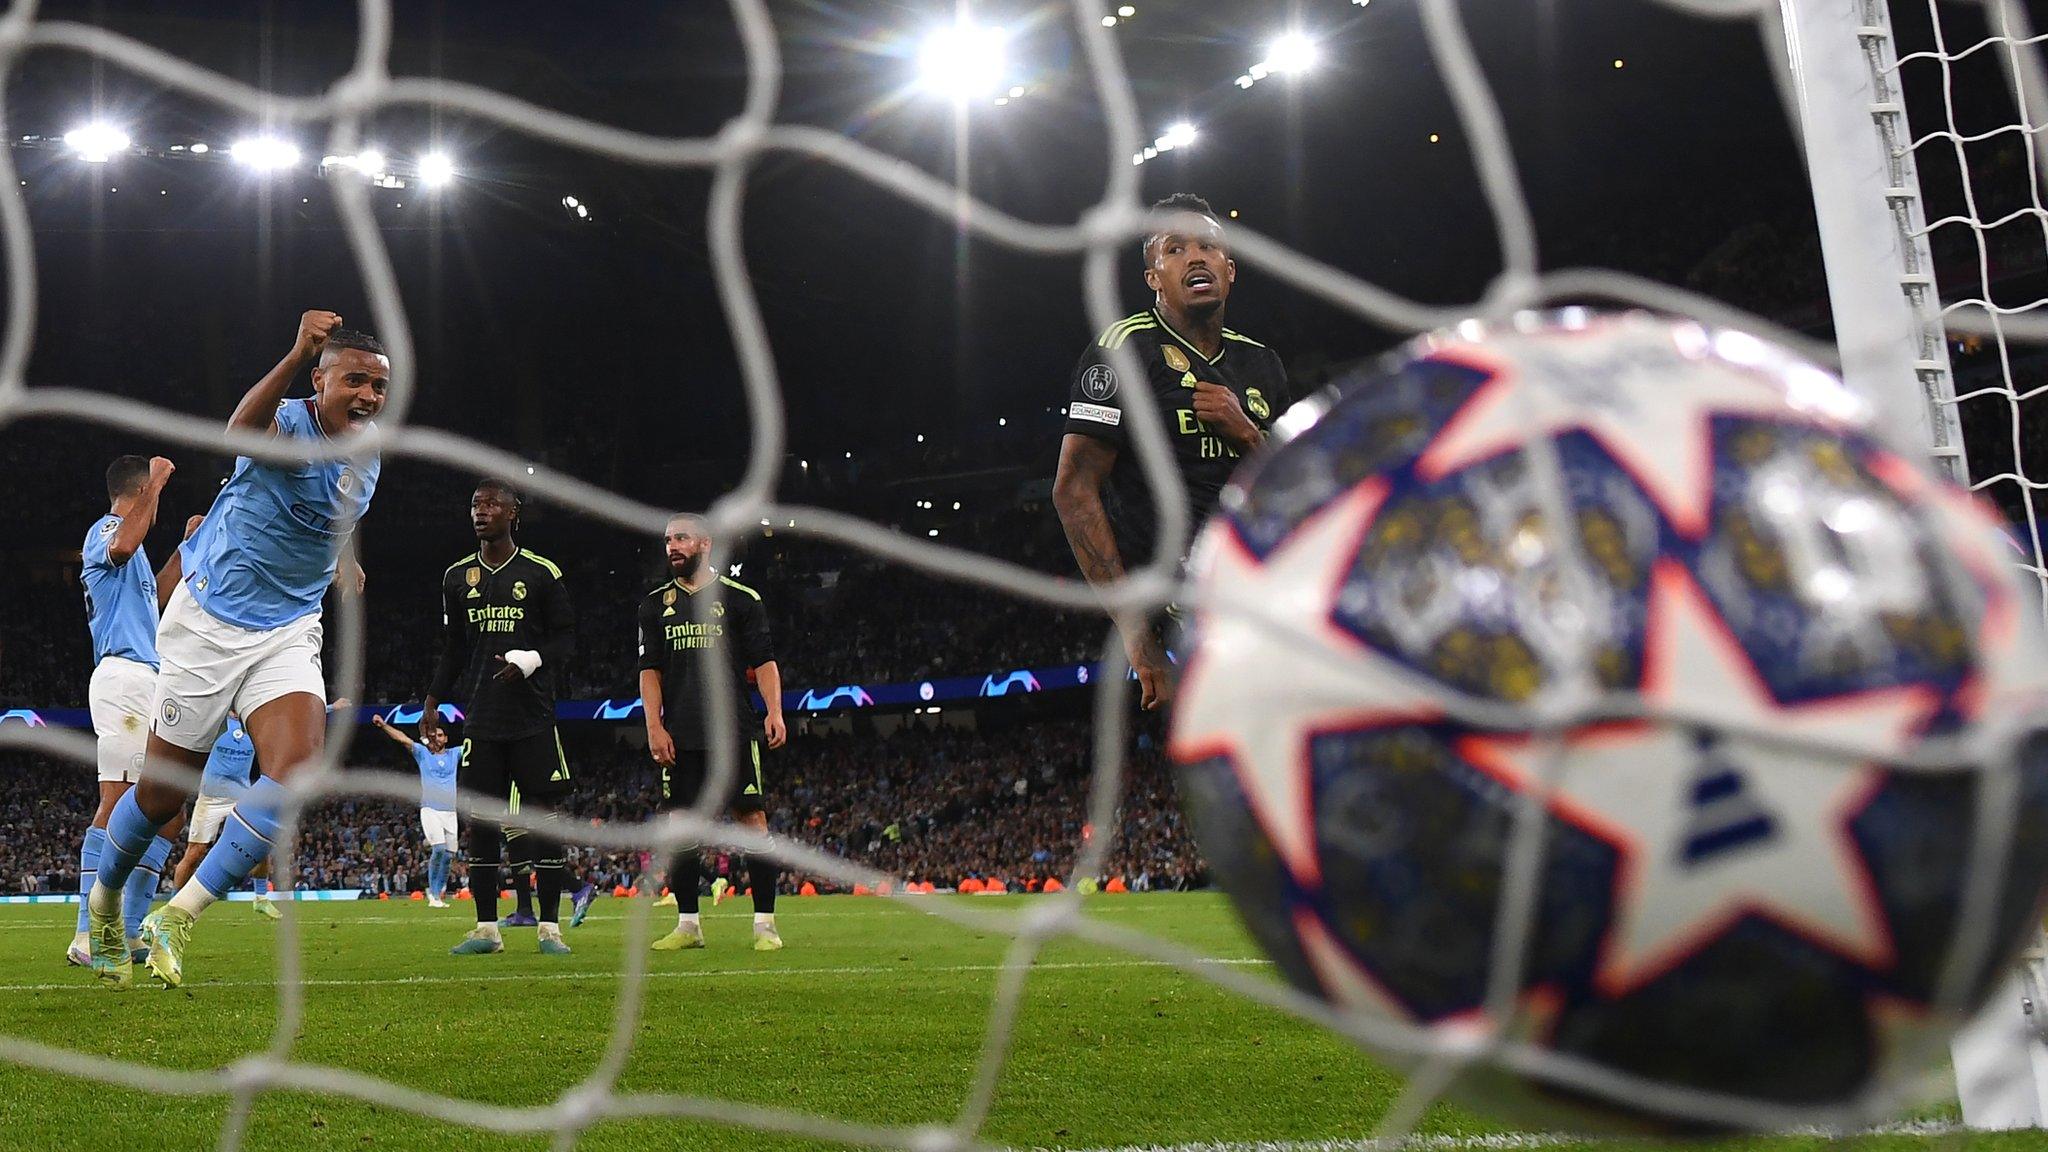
[63, 455, 191, 965]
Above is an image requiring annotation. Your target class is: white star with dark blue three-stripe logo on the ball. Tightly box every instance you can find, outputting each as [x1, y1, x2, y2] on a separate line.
[1458, 560, 1935, 996]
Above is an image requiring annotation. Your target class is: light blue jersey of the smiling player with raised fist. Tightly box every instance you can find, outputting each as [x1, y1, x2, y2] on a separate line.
[182, 398, 381, 631]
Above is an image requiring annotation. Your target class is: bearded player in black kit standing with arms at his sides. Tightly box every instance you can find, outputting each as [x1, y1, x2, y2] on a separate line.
[639, 515, 788, 951]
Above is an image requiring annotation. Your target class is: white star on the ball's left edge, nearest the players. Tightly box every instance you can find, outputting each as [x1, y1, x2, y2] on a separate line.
[1167, 480, 1440, 886]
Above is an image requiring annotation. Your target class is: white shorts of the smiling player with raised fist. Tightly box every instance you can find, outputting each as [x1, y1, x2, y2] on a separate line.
[150, 584, 328, 754]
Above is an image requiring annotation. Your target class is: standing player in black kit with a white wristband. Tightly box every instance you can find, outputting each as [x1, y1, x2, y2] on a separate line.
[420, 480, 575, 955]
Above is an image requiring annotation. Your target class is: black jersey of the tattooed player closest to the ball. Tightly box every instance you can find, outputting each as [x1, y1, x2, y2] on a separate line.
[1067, 310, 1292, 568]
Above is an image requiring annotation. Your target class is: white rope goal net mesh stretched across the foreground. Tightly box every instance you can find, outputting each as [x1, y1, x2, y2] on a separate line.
[0, 0, 2048, 1150]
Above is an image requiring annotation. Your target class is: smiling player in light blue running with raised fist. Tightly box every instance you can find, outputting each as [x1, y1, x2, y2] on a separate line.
[88, 312, 391, 986]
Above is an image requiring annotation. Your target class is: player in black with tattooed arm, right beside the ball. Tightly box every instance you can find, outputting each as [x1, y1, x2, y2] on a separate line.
[1053, 193, 1292, 709]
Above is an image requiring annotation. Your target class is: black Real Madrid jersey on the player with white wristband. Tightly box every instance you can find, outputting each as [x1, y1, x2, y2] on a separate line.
[428, 549, 575, 740]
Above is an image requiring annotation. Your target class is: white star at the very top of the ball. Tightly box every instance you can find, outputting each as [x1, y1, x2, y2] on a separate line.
[1415, 330, 1810, 539]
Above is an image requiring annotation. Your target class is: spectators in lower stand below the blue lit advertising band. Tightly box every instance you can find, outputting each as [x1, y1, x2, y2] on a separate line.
[0, 719, 1206, 896]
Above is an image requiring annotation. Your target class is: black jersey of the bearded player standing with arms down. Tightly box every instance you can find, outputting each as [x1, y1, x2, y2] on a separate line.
[639, 576, 774, 748]
